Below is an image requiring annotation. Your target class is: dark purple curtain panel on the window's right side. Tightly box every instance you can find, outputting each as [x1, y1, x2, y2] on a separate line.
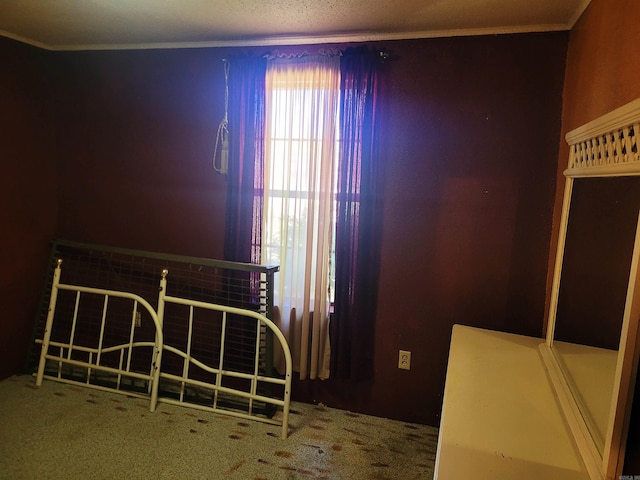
[330, 48, 382, 380]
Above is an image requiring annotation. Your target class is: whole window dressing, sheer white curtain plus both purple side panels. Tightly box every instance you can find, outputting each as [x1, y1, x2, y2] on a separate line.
[225, 47, 386, 380]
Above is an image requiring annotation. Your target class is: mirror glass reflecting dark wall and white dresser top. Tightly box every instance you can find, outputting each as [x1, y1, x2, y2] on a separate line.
[552, 177, 640, 455]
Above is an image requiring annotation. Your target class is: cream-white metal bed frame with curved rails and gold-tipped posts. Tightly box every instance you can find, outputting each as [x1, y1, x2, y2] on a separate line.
[36, 260, 292, 439]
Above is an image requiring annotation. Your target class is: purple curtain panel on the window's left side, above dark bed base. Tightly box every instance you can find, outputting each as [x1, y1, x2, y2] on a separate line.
[224, 57, 267, 263]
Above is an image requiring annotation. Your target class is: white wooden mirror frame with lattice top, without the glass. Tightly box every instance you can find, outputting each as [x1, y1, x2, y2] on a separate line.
[540, 98, 640, 480]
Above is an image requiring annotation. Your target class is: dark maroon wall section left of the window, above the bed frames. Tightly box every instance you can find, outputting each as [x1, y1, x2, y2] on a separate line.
[56, 49, 231, 258]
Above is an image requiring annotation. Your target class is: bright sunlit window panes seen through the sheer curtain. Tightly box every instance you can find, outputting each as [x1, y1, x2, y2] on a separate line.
[262, 57, 339, 301]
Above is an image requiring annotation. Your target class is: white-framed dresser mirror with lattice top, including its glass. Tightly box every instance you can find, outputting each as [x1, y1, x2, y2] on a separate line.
[540, 94, 640, 480]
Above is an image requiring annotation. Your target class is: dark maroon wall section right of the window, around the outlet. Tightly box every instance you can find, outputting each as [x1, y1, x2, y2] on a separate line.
[294, 33, 567, 425]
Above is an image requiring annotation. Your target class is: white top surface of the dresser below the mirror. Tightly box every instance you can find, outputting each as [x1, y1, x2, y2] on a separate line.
[434, 325, 589, 480]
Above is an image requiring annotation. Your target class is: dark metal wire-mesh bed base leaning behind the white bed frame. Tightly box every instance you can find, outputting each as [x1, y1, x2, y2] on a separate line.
[24, 239, 283, 394]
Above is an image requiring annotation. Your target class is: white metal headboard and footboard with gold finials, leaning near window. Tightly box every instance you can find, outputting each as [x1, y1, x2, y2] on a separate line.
[36, 260, 292, 439]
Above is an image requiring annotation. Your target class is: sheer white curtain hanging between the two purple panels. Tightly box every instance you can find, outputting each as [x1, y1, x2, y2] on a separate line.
[262, 55, 340, 379]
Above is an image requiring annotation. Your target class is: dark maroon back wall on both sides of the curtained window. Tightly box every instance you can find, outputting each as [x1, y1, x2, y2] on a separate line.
[2, 33, 567, 425]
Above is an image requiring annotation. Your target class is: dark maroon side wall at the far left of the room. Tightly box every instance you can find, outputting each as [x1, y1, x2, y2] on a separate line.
[0, 37, 57, 379]
